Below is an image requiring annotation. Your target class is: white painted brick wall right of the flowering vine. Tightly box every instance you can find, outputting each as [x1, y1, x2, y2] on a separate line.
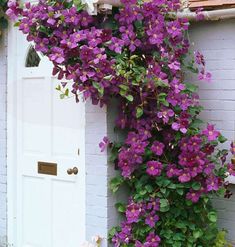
[190, 20, 235, 245]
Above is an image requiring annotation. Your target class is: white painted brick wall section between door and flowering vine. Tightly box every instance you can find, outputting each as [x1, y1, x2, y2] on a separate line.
[86, 99, 124, 247]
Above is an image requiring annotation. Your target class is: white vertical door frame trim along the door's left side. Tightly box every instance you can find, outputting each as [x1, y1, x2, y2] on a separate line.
[7, 24, 17, 247]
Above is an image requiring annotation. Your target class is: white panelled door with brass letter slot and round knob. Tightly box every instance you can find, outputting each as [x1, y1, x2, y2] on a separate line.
[10, 29, 85, 247]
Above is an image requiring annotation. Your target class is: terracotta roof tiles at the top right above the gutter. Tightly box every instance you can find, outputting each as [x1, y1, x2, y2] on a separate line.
[189, 0, 235, 9]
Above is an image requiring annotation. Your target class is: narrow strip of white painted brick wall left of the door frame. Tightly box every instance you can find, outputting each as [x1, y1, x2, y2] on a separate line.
[0, 30, 7, 247]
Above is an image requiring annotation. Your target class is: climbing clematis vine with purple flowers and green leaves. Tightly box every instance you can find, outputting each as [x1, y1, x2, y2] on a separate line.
[7, 0, 234, 247]
